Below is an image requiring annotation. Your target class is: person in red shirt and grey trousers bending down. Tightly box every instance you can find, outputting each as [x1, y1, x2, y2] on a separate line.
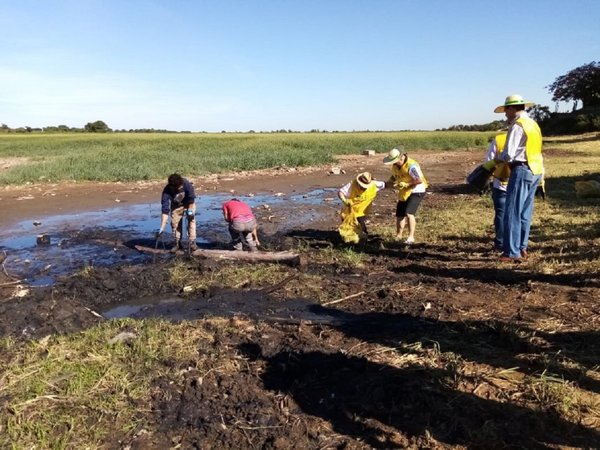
[223, 198, 260, 252]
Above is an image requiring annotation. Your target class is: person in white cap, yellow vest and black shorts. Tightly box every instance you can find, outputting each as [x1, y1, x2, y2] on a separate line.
[383, 147, 428, 244]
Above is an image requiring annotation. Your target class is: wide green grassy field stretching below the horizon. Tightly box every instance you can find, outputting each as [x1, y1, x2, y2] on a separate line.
[0, 132, 490, 185]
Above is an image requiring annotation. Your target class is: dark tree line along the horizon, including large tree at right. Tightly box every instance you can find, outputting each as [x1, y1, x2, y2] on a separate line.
[0, 61, 600, 134]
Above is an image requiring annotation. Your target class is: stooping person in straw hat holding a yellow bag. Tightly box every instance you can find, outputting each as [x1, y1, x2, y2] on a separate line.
[338, 172, 385, 243]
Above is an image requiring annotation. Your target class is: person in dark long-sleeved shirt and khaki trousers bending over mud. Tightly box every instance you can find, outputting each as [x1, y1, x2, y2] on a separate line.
[157, 173, 198, 252]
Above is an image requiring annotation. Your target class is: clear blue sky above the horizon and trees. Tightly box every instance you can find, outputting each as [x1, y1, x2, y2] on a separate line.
[0, 0, 600, 131]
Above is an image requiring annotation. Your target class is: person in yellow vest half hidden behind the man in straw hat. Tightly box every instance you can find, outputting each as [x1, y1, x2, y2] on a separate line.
[483, 133, 510, 251]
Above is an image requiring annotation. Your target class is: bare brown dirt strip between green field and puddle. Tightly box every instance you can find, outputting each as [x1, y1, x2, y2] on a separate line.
[0, 152, 481, 226]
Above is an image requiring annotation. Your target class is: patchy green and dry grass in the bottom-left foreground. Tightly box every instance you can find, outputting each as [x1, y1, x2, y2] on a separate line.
[0, 320, 220, 449]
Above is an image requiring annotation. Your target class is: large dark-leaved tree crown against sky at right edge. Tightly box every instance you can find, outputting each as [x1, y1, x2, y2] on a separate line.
[546, 61, 600, 110]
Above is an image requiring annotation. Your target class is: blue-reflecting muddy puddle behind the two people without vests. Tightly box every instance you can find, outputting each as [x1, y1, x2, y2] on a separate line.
[0, 189, 336, 286]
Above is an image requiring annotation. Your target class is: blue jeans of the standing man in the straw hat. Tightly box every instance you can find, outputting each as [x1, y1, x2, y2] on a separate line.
[503, 166, 542, 258]
